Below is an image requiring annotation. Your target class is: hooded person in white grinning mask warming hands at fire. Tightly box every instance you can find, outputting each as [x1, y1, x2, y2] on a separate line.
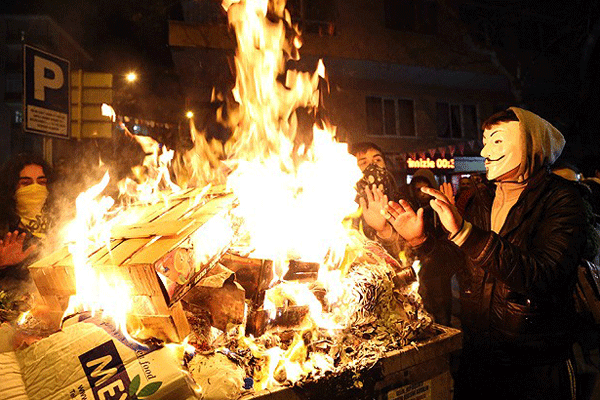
[366, 107, 589, 400]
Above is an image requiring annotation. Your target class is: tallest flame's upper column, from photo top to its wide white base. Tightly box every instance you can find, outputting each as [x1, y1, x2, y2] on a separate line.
[224, 0, 360, 268]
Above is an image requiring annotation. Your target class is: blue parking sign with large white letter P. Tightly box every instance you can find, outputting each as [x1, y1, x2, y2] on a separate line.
[23, 45, 71, 139]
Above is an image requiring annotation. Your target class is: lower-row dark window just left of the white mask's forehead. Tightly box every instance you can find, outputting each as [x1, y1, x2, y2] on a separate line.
[436, 102, 478, 139]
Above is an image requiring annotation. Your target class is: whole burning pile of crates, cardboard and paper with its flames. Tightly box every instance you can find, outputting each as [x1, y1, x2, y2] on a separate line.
[0, 0, 454, 399]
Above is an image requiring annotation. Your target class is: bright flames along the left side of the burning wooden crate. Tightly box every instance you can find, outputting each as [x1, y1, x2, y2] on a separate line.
[64, 135, 186, 339]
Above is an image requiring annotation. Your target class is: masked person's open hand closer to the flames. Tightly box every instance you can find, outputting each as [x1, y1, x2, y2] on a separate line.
[386, 200, 427, 247]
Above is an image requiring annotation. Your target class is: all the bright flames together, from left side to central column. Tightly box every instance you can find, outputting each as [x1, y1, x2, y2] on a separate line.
[49, 0, 424, 390]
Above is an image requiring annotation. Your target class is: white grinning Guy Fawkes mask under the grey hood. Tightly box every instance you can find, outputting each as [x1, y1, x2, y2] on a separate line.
[481, 121, 523, 180]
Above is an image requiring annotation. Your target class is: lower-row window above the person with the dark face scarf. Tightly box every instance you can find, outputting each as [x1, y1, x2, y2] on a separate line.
[367, 96, 415, 136]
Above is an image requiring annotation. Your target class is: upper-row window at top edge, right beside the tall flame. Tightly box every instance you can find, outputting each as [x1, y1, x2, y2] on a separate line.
[286, 0, 335, 36]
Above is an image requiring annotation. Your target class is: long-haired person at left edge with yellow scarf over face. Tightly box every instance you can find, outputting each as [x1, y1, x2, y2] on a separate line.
[0, 153, 52, 290]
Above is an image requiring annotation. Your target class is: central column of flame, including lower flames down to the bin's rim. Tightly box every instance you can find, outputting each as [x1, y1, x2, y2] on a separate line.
[199, 0, 376, 389]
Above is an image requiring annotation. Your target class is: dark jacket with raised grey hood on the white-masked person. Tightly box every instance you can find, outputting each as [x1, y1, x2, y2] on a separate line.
[415, 107, 586, 365]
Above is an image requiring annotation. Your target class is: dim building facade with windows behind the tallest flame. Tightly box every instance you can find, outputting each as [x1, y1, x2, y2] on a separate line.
[170, 0, 513, 181]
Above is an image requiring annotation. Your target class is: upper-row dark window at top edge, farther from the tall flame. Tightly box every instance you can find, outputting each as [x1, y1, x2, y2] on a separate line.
[384, 0, 437, 35]
